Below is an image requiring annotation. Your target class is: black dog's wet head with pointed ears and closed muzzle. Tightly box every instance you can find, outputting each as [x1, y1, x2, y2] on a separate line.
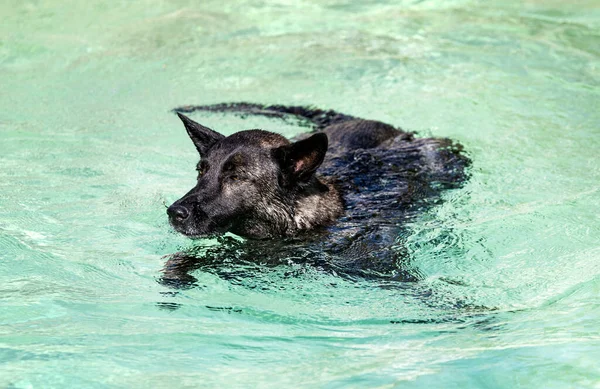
[167, 113, 327, 238]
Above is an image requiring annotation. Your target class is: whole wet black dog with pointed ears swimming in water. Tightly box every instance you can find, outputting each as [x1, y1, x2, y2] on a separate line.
[163, 103, 469, 286]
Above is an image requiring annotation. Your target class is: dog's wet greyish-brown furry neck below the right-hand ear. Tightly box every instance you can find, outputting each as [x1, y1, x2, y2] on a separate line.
[292, 177, 344, 233]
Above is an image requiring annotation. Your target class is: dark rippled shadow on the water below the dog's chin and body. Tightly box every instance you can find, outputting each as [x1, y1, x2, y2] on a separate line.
[160, 227, 419, 289]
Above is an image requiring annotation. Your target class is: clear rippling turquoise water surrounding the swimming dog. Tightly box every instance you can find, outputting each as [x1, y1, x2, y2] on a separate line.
[0, 0, 600, 388]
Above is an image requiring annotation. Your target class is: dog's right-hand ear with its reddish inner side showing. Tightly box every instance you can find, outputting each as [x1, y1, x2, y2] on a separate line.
[273, 132, 328, 181]
